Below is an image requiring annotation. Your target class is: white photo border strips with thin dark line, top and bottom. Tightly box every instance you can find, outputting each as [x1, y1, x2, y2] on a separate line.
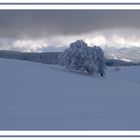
[0, 0, 140, 138]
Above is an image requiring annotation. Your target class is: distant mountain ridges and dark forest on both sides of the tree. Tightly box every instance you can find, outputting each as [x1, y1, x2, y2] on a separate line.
[0, 48, 140, 66]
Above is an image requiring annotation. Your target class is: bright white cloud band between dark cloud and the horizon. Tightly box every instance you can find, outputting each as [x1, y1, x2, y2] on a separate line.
[0, 29, 140, 52]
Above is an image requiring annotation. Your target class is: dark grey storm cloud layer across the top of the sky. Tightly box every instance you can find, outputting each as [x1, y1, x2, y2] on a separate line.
[0, 10, 140, 38]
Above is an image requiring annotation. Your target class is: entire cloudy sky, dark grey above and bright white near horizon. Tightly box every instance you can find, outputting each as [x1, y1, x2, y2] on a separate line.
[0, 10, 140, 51]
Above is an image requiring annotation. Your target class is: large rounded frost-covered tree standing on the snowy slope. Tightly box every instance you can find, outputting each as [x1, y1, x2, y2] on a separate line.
[58, 40, 105, 74]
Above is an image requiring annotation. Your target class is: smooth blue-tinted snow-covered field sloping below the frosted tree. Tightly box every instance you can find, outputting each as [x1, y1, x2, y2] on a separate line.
[0, 59, 140, 130]
